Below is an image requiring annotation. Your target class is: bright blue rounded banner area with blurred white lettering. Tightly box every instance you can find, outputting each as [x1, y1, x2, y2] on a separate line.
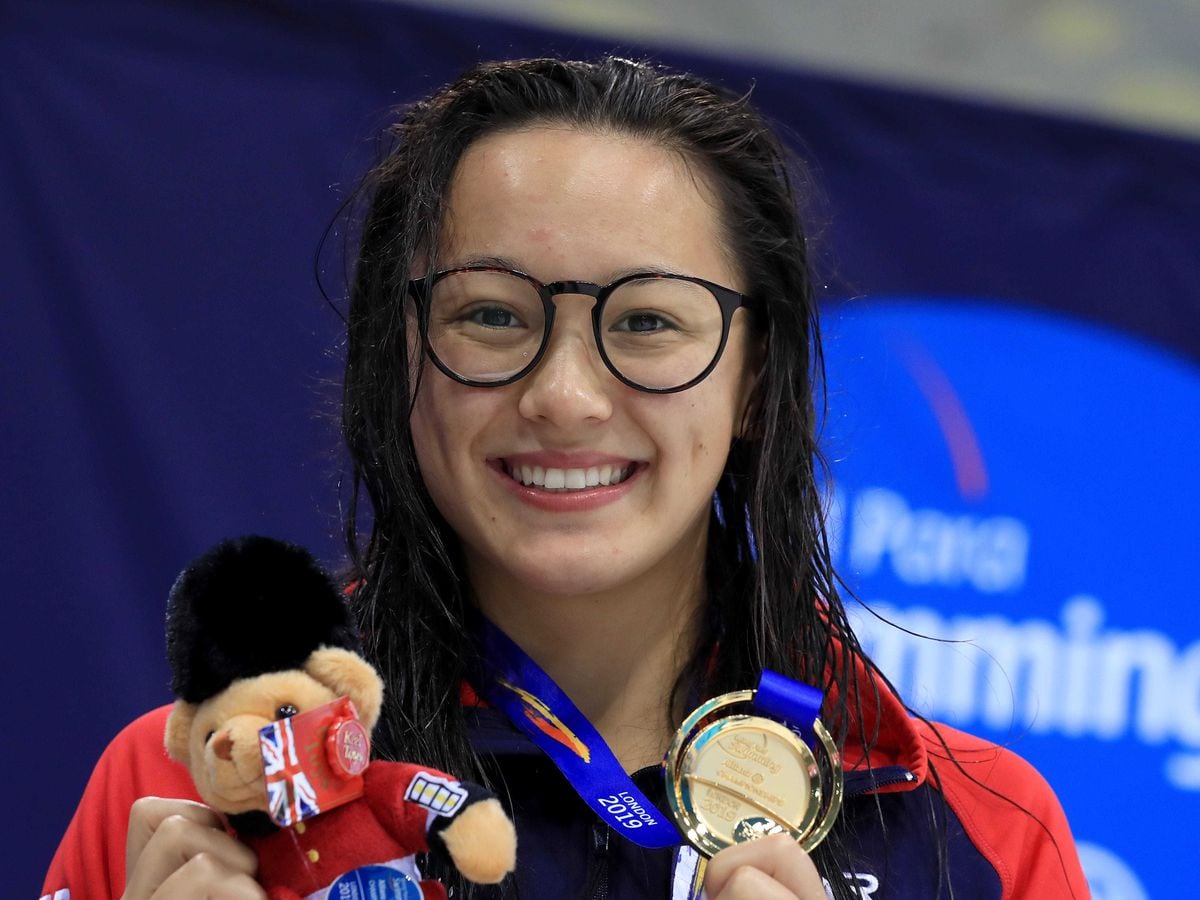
[827, 298, 1200, 900]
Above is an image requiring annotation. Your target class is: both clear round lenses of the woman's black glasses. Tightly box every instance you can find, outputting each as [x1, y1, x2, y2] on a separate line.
[428, 271, 724, 390]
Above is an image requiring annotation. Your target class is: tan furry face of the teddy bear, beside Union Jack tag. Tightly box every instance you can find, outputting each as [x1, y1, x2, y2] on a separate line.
[174, 671, 337, 814]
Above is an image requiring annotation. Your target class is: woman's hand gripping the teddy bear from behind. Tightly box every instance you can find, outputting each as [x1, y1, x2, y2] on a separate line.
[124, 797, 266, 900]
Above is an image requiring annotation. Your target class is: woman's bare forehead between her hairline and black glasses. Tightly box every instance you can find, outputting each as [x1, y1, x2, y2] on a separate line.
[439, 126, 737, 287]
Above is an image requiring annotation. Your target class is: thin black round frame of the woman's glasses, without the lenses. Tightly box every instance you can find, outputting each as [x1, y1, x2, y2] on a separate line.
[408, 265, 762, 394]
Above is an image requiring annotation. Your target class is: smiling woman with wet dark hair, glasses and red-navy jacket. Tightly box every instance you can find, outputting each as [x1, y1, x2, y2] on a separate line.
[48, 59, 1087, 900]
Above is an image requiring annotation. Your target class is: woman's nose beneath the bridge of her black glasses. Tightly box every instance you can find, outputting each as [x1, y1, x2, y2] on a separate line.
[517, 298, 616, 427]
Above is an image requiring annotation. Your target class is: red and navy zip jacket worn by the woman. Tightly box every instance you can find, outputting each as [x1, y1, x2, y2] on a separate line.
[44, 694, 1090, 900]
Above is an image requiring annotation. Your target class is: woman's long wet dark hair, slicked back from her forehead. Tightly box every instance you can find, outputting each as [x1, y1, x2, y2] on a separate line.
[343, 58, 902, 896]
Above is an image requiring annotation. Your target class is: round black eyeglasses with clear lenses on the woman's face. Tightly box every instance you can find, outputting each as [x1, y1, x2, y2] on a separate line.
[408, 265, 756, 394]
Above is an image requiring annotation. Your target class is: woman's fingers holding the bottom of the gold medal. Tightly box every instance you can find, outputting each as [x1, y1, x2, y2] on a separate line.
[704, 834, 828, 900]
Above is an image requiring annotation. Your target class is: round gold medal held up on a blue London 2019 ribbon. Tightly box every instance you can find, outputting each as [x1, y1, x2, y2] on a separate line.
[662, 691, 842, 856]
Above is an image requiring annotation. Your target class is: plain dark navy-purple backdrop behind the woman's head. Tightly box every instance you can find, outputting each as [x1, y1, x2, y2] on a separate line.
[0, 0, 1200, 896]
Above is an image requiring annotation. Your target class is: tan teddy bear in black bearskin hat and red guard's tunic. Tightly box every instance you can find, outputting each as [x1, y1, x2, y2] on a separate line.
[166, 536, 516, 900]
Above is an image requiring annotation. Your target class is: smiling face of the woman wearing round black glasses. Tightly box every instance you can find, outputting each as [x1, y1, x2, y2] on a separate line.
[412, 126, 756, 619]
